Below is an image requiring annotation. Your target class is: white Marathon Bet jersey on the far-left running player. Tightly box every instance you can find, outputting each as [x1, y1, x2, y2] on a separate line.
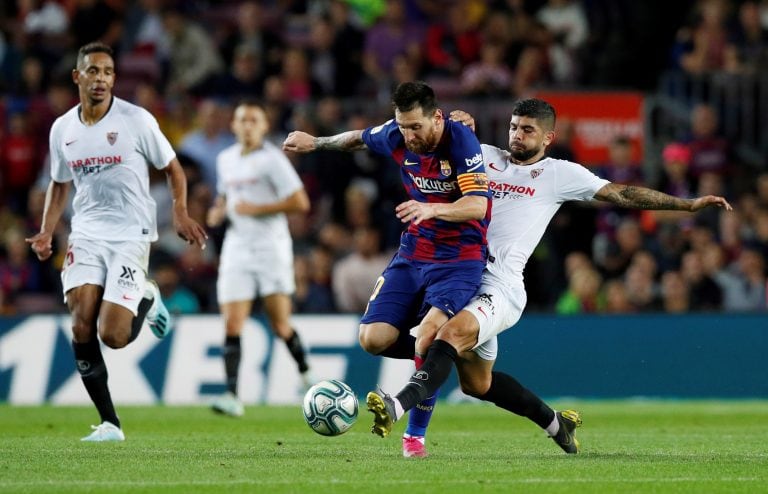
[50, 97, 176, 242]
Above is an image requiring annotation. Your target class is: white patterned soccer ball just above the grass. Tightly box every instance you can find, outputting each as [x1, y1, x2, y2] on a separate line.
[303, 379, 358, 436]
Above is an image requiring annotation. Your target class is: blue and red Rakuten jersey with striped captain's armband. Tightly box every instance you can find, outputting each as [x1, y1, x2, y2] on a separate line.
[363, 119, 491, 262]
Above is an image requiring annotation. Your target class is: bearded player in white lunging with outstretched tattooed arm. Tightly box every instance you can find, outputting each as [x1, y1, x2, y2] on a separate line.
[366, 99, 731, 454]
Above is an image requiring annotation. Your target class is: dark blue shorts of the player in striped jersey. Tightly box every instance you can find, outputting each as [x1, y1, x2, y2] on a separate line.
[360, 255, 485, 331]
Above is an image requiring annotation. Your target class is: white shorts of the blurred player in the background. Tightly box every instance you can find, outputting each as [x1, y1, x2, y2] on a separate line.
[216, 233, 296, 305]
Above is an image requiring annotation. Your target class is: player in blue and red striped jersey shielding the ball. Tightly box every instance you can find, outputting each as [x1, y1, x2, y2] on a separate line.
[283, 82, 491, 456]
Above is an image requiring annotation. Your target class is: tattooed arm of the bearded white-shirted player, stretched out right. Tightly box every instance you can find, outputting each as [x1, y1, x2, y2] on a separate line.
[595, 184, 733, 212]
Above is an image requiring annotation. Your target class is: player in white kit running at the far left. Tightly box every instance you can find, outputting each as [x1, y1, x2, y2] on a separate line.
[27, 43, 207, 441]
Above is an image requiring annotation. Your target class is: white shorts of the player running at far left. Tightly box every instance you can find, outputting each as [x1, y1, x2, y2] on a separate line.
[61, 239, 149, 315]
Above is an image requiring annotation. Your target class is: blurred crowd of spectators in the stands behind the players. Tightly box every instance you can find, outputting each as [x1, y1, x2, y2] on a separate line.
[0, 0, 768, 315]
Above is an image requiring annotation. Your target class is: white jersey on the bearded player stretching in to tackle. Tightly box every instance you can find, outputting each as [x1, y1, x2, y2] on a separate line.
[482, 144, 610, 283]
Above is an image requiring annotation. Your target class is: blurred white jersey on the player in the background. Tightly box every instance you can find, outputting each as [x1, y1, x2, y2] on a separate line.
[216, 142, 304, 255]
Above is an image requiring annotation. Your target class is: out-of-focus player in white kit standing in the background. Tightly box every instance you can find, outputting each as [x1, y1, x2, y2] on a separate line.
[208, 101, 312, 417]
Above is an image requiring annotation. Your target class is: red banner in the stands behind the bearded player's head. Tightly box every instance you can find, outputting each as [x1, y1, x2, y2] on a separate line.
[536, 92, 643, 165]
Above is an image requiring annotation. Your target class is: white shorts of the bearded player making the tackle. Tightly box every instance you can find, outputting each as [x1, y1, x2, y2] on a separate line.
[464, 281, 528, 360]
